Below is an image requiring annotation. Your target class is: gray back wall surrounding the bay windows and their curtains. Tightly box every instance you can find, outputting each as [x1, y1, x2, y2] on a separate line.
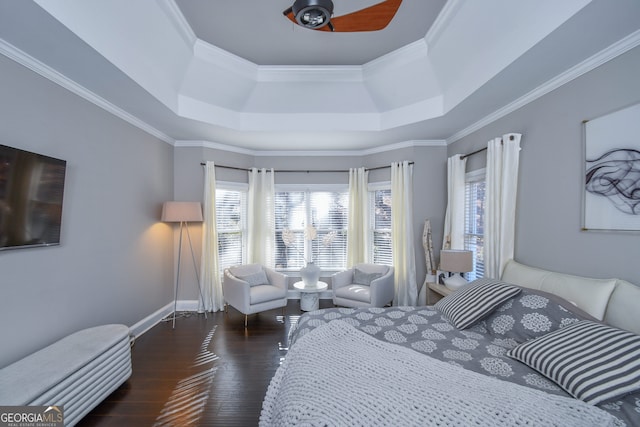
[174, 146, 447, 300]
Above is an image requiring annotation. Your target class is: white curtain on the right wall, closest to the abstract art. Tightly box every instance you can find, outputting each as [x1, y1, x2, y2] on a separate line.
[484, 133, 522, 278]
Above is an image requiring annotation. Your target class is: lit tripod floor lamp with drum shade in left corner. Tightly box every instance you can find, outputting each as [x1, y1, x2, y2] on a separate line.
[162, 202, 207, 329]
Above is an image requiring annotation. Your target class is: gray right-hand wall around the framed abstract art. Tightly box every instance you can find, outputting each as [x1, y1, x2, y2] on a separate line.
[449, 48, 640, 285]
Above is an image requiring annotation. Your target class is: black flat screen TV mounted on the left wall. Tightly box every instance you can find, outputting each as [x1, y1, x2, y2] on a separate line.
[0, 145, 67, 251]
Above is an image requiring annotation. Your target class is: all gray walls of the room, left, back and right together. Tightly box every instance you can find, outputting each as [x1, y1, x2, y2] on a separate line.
[0, 20, 640, 372]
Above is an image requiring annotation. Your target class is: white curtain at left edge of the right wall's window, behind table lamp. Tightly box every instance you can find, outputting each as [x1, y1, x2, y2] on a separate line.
[442, 154, 467, 249]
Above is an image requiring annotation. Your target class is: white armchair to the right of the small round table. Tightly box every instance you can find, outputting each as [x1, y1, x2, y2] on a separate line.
[331, 263, 395, 307]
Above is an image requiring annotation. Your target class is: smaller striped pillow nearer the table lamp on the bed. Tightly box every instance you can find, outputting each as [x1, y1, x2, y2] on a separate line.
[434, 279, 520, 329]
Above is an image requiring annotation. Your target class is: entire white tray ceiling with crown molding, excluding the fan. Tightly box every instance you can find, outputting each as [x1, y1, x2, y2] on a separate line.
[0, 0, 640, 152]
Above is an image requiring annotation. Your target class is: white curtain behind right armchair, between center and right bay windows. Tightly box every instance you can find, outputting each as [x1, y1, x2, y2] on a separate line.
[347, 168, 369, 268]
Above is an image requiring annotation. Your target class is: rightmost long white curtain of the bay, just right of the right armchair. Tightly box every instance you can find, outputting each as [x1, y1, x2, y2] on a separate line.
[391, 161, 418, 306]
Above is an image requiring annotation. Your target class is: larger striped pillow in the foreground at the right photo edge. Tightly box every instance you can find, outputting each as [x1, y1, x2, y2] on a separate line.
[507, 320, 640, 405]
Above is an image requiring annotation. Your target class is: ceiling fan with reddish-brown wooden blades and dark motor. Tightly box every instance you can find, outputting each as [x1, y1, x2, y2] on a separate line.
[282, 0, 402, 32]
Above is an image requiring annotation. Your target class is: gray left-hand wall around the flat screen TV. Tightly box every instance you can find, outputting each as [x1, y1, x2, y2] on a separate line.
[0, 55, 173, 367]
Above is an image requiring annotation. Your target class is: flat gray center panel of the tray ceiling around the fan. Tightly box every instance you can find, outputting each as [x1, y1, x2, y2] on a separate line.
[176, 0, 446, 65]
